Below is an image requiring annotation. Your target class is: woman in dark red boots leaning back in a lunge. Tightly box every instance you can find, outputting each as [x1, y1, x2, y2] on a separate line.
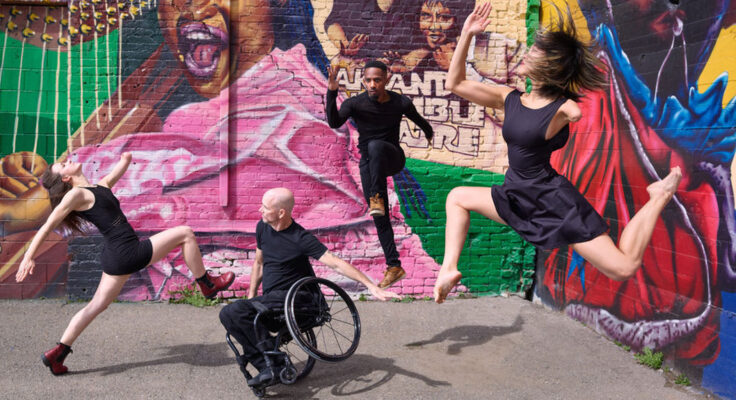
[15, 153, 235, 375]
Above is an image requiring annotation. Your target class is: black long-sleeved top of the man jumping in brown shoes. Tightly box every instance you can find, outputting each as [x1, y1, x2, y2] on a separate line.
[325, 90, 434, 152]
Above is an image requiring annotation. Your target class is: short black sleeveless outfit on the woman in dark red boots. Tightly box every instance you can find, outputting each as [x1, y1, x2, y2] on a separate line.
[78, 185, 153, 275]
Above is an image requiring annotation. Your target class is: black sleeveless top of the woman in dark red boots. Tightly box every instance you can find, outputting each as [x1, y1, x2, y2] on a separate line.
[79, 185, 138, 243]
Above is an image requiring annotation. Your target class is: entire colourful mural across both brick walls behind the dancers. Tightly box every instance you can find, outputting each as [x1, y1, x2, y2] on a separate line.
[0, 0, 736, 397]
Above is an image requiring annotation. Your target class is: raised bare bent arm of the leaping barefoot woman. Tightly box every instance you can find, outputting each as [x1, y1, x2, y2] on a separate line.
[445, 3, 513, 108]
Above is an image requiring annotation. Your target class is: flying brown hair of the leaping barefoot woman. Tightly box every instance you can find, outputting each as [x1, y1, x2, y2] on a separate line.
[528, 4, 608, 101]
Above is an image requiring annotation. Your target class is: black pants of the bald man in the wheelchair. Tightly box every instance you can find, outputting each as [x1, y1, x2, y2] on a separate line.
[220, 290, 320, 371]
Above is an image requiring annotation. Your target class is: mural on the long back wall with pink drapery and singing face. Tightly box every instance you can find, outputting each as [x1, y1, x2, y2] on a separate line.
[0, 0, 534, 300]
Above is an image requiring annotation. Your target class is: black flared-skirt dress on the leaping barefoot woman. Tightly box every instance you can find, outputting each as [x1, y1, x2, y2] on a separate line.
[491, 90, 608, 249]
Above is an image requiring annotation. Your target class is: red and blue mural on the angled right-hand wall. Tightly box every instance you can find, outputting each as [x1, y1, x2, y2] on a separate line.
[537, 0, 736, 394]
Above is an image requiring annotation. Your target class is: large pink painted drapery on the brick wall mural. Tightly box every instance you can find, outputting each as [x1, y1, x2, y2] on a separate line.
[76, 45, 458, 300]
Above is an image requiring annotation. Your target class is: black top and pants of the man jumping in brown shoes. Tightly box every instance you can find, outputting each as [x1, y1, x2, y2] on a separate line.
[325, 90, 434, 267]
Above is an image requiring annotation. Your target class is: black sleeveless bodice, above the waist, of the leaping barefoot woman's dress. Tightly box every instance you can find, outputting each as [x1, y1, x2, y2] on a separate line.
[502, 90, 570, 175]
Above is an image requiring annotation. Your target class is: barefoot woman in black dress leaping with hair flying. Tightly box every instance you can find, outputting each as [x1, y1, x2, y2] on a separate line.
[434, 3, 682, 303]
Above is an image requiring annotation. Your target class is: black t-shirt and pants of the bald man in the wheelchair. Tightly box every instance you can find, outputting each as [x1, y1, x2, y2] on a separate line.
[220, 221, 327, 371]
